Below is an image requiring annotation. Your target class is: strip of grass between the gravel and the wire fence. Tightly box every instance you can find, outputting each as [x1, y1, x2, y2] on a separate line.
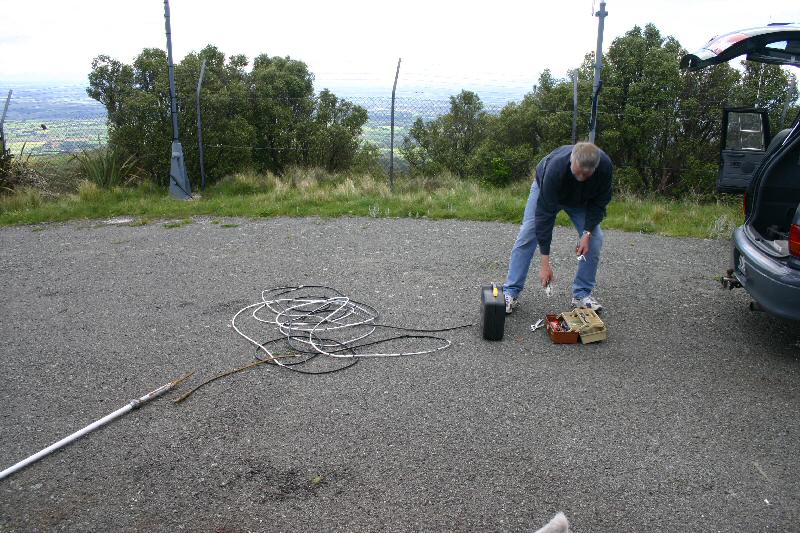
[0, 169, 743, 238]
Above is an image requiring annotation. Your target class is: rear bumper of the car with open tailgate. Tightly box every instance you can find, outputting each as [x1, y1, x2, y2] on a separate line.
[733, 226, 800, 320]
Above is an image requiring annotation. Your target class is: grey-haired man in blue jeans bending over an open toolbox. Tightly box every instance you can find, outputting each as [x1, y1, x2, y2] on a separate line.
[503, 142, 613, 314]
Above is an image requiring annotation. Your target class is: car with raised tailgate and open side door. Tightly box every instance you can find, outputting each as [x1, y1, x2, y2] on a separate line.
[681, 23, 800, 321]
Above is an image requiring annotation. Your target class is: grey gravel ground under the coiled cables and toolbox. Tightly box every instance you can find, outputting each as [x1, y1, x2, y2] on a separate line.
[0, 214, 800, 533]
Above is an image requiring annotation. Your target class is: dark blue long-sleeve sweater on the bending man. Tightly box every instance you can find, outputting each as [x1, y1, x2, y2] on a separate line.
[534, 145, 614, 255]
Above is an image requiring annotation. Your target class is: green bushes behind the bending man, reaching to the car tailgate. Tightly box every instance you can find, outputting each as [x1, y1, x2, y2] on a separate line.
[422, 24, 794, 197]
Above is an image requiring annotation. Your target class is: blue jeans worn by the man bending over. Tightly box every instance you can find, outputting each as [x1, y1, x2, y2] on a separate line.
[503, 180, 603, 298]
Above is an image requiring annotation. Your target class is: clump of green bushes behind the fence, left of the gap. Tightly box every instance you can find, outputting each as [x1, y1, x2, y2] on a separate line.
[87, 46, 368, 185]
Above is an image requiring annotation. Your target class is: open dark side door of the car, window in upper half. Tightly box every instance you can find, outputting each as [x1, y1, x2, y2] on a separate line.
[717, 108, 770, 194]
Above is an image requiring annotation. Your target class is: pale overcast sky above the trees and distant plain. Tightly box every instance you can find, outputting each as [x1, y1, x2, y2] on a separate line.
[0, 0, 800, 93]
